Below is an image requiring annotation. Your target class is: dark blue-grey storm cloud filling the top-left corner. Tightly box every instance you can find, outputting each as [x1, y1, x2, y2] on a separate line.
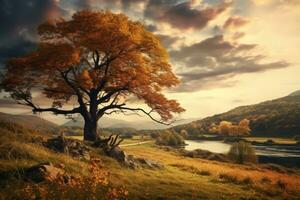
[0, 0, 64, 64]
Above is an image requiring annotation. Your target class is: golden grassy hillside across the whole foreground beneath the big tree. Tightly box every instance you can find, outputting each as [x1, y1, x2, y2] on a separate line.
[0, 119, 300, 200]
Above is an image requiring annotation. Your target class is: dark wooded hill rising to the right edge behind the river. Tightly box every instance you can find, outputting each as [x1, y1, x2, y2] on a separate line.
[173, 94, 300, 137]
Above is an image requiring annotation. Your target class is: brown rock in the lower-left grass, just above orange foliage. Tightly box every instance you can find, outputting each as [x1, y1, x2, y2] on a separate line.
[25, 163, 65, 182]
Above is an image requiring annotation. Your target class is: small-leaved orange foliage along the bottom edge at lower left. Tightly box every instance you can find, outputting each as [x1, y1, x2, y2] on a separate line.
[16, 159, 128, 200]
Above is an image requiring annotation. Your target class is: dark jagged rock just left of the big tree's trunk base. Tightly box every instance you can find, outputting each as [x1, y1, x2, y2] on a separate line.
[44, 136, 90, 160]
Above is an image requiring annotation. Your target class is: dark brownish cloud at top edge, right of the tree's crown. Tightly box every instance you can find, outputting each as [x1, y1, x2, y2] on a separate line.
[145, 0, 231, 29]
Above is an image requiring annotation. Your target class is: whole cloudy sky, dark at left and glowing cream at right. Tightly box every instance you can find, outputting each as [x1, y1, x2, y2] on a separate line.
[0, 0, 300, 123]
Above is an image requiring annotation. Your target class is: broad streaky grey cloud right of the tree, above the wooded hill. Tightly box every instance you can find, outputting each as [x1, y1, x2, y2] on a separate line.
[170, 35, 289, 91]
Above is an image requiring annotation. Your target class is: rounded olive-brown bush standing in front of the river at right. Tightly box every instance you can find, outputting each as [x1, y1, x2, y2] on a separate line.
[228, 141, 257, 164]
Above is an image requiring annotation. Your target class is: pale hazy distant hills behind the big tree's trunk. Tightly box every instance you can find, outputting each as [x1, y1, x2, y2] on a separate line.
[62, 116, 195, 130]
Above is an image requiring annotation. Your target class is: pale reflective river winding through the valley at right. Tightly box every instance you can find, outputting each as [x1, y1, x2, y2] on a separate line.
[185, 140, 300, 167]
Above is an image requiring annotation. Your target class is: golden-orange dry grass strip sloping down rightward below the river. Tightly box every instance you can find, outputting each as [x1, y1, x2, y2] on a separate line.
[126, 142, 300, 197]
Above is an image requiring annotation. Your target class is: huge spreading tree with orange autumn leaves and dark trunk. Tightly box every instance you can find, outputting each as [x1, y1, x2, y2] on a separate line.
[1, 11, 184, 140]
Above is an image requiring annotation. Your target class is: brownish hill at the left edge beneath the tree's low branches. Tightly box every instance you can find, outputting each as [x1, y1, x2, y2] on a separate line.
[0, 112, 59, 132]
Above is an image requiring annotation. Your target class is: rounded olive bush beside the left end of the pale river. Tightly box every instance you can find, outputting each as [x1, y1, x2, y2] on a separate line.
[156, 130, 185, 146]
